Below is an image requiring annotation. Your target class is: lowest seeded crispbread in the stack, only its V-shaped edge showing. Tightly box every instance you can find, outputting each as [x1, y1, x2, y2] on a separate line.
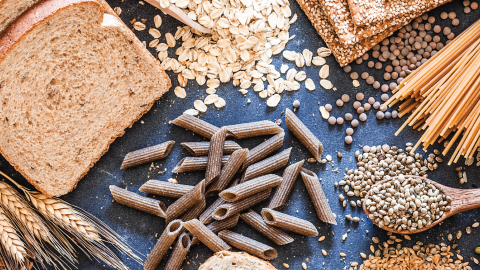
[297, 0, 450, 67]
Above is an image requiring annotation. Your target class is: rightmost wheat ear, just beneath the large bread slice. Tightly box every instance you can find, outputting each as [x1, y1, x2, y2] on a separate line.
[25, 191, 100, 241]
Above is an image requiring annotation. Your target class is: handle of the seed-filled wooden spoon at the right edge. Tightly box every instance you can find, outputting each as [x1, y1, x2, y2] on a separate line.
[447, 188, 480, 216]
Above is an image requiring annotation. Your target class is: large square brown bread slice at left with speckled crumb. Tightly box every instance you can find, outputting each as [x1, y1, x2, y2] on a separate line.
[0, 0, 170, 196]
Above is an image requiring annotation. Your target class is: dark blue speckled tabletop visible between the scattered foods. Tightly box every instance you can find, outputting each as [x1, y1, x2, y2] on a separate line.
[0, 0, 480, 269]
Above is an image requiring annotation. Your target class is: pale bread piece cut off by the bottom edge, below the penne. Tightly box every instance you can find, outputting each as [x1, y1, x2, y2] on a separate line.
[198, 251, 277, 270]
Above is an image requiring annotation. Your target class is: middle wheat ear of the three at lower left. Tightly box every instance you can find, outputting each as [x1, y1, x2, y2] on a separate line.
[0, 182, 50, 243]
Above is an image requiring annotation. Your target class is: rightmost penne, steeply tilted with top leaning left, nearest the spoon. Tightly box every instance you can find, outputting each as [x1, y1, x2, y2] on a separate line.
[301, 168, 337, 225]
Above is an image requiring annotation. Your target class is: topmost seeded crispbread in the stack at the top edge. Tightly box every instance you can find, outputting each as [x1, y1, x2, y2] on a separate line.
[347, 0, 450, 26]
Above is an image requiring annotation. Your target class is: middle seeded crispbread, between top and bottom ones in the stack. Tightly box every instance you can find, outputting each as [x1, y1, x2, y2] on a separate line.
[319, 0, 449, 44]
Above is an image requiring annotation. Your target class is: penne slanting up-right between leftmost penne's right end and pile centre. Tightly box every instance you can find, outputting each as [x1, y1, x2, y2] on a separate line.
[166, 180, 205, 223]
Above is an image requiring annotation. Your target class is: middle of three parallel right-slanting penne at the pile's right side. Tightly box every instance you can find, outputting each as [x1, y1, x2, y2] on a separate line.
[240, 147, 292, 182]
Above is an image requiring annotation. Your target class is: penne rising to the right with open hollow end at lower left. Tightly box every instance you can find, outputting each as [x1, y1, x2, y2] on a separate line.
[212, 189, 272, 220]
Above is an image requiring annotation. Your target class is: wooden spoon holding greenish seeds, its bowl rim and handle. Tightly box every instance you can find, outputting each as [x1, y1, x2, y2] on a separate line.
[363, 175, 480, 234]
